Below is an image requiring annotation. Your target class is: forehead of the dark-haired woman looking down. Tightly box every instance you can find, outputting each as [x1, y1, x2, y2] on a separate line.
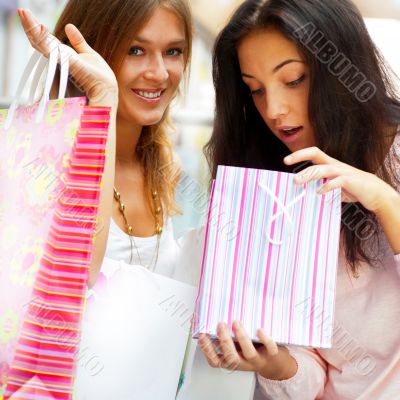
[237, 28, 303, 71]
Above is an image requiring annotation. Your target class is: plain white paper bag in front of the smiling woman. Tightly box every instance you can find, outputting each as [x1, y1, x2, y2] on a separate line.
[74, 259, 196, 400]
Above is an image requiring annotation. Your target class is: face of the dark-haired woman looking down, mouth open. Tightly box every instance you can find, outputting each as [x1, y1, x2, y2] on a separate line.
[238, 28, 315, 152]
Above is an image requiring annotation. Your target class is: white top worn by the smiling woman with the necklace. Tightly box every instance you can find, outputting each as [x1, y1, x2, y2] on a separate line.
[105, 218, 177, 277]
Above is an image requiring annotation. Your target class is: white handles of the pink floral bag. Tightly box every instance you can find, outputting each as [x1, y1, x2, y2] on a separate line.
[4, 43, 69, 129]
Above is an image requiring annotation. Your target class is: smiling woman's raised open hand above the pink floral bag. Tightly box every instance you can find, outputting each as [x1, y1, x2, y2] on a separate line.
[18, 9, 118, 106]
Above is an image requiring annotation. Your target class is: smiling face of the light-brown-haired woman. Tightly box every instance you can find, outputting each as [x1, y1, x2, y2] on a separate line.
[117, 7, 186, 126]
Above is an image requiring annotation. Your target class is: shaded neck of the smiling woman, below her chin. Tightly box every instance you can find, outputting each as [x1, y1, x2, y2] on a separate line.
[116, 118, 143, 166]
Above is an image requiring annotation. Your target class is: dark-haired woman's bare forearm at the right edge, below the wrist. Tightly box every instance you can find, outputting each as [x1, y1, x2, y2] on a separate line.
[376, 186, 400, 254]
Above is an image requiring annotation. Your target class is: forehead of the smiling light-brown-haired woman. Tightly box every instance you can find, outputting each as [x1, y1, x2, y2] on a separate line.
[134, 6, 185, 40]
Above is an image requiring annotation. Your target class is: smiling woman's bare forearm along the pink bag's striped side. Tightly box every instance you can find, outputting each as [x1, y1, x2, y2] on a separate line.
[89, 95, 118, 287]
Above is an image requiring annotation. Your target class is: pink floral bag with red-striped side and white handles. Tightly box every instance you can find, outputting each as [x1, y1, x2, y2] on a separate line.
[0, 46, 110, 400]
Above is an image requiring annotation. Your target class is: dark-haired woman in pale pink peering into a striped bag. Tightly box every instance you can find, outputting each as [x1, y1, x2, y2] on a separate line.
[200, 0, 400, 400]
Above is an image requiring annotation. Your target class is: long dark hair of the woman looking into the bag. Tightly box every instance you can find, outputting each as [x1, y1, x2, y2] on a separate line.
[205, 0, 400, 272]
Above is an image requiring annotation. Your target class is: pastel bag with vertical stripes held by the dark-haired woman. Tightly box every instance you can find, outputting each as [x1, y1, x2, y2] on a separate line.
[193, 166, 341, 348]
